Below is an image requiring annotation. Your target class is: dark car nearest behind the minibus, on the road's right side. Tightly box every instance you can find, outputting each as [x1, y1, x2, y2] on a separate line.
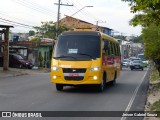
[130, 60, 144, 70]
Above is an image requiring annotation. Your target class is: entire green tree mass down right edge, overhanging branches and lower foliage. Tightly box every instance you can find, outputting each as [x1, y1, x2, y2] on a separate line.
[122, 0, 160, 76]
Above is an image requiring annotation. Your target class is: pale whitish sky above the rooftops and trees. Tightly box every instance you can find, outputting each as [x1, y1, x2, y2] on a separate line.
[0, 0, 141, 36]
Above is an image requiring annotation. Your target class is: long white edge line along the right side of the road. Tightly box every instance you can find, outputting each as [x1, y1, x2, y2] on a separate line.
[121, 69, 148, 120]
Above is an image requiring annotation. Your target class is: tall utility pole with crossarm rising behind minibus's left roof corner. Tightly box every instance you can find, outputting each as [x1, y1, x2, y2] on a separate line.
[54, 0, 73, 38]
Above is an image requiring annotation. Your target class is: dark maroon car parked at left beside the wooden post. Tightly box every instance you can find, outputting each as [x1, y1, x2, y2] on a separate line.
[9, 54, 33, 69]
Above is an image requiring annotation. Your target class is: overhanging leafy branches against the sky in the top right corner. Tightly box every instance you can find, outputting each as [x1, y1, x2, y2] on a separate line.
[122, 0, 160, 27]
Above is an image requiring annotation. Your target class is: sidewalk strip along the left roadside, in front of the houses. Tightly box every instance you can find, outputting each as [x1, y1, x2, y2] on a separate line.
[0, 67, 50, 79]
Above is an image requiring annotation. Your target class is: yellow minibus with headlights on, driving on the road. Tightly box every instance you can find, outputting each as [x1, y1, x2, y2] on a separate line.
[51, 30, 121, 92]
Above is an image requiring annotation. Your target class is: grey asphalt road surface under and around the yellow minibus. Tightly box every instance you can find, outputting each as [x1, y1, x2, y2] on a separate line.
[0, 68, 148, 120]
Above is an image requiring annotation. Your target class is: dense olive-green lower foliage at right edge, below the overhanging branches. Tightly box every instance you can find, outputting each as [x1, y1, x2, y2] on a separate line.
[142, 24, 160, 76]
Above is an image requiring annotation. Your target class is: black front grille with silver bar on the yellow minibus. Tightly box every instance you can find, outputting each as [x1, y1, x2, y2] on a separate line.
[63, 68, 86, 81]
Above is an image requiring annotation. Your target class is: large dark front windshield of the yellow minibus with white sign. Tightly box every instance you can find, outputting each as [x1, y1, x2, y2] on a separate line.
[53, 35, 100, 60]
